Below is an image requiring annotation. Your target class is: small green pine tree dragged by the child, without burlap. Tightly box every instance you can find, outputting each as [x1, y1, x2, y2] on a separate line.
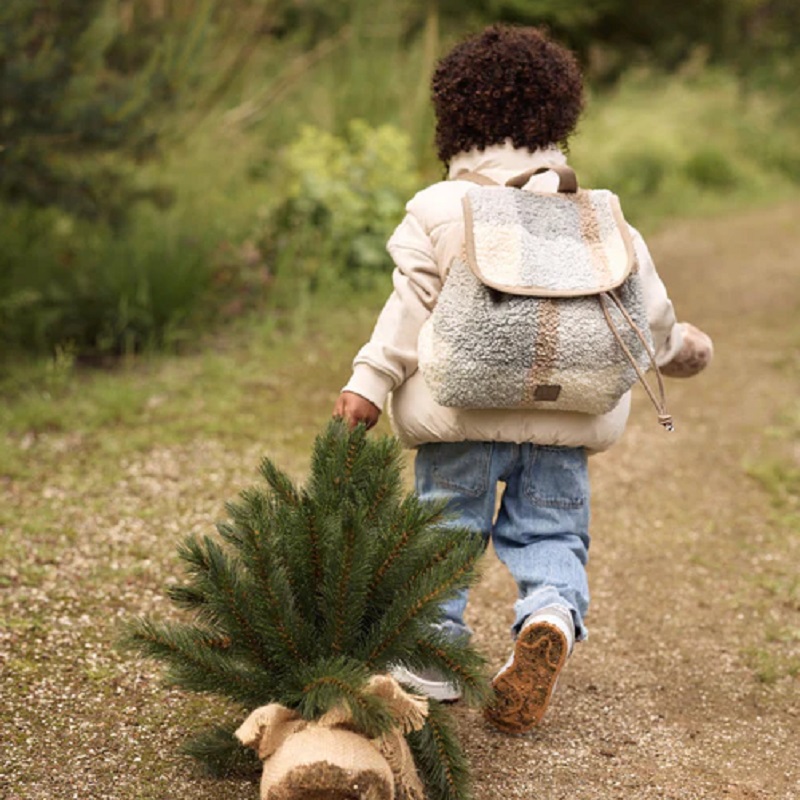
[126, 421, 485, 800]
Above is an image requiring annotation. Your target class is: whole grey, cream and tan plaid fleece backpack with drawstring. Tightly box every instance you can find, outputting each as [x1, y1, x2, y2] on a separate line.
[419, 166, 672, 430]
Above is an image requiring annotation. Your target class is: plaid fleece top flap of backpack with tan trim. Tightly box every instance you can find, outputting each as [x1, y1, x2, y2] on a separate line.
[463, 186, 635, 297]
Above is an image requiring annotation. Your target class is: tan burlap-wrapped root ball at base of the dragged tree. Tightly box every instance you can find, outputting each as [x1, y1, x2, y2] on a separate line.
[236, 675, 428, 800]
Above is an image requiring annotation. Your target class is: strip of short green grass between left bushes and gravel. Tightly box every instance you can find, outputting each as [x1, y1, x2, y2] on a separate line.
[0, 285, 388, 479]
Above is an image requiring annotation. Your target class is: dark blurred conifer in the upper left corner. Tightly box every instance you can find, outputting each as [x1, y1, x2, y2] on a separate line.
[0, 0, 213, 225]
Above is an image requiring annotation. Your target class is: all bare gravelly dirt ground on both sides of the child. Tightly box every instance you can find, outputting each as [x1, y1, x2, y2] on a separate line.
[0, 205, 800, 800]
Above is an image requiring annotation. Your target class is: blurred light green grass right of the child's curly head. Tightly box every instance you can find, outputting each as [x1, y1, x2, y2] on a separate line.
[571, 69, 800, 230]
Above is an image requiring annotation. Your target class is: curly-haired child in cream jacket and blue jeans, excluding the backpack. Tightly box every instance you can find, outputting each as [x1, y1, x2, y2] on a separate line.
[334, 26, 711, 733]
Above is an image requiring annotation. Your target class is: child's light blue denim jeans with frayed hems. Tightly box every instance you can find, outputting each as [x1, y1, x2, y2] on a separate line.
[415, 442, 589, 640]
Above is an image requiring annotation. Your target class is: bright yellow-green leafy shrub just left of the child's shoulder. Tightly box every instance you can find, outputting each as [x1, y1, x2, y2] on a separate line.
[259, 120, 420, 288]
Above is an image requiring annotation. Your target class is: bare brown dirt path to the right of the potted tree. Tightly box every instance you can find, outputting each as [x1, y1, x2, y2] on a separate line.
[461, 203, 800, 800]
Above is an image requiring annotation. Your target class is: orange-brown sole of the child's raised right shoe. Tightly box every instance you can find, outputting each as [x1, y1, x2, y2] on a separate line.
[484, 622, 567, 733]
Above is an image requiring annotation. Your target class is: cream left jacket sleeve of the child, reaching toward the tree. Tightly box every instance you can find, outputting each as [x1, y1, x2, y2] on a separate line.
[343, 204, 442, 408]
